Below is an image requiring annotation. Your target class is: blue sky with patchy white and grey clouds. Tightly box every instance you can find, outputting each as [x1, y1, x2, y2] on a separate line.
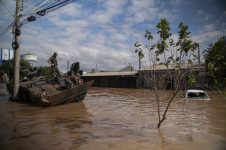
[0, 0, 226, 72]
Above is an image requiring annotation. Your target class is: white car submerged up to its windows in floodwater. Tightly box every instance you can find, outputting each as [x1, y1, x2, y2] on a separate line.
[184, 89, 210, 100]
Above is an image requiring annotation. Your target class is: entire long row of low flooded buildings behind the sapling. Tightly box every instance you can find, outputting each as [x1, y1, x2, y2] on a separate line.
[81, 64, 206, 89]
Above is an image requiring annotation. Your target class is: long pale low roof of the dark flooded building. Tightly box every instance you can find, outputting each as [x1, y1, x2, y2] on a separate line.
[82, 71, 137, 77]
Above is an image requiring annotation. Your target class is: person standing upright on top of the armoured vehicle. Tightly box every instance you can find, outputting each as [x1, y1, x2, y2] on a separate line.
[48, 52, 60, 78]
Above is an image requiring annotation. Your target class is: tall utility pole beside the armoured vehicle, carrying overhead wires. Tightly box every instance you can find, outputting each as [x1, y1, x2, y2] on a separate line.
[12, 0, 21, 99]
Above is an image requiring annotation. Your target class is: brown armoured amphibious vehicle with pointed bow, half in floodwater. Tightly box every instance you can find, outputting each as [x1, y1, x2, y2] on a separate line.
[11, 64, 93, 106]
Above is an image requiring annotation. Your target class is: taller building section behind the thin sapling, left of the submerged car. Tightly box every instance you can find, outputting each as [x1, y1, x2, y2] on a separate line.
[138, 64, 206, 89]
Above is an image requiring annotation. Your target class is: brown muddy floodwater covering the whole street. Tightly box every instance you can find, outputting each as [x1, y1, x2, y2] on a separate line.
[0, 88, 226, 150]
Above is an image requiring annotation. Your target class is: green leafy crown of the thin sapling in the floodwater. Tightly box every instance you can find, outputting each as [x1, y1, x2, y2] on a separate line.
[141, 19, 198, 70]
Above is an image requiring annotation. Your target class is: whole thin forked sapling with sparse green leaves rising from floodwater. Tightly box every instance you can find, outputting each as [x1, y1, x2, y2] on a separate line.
[135, 19, 197, 128]
